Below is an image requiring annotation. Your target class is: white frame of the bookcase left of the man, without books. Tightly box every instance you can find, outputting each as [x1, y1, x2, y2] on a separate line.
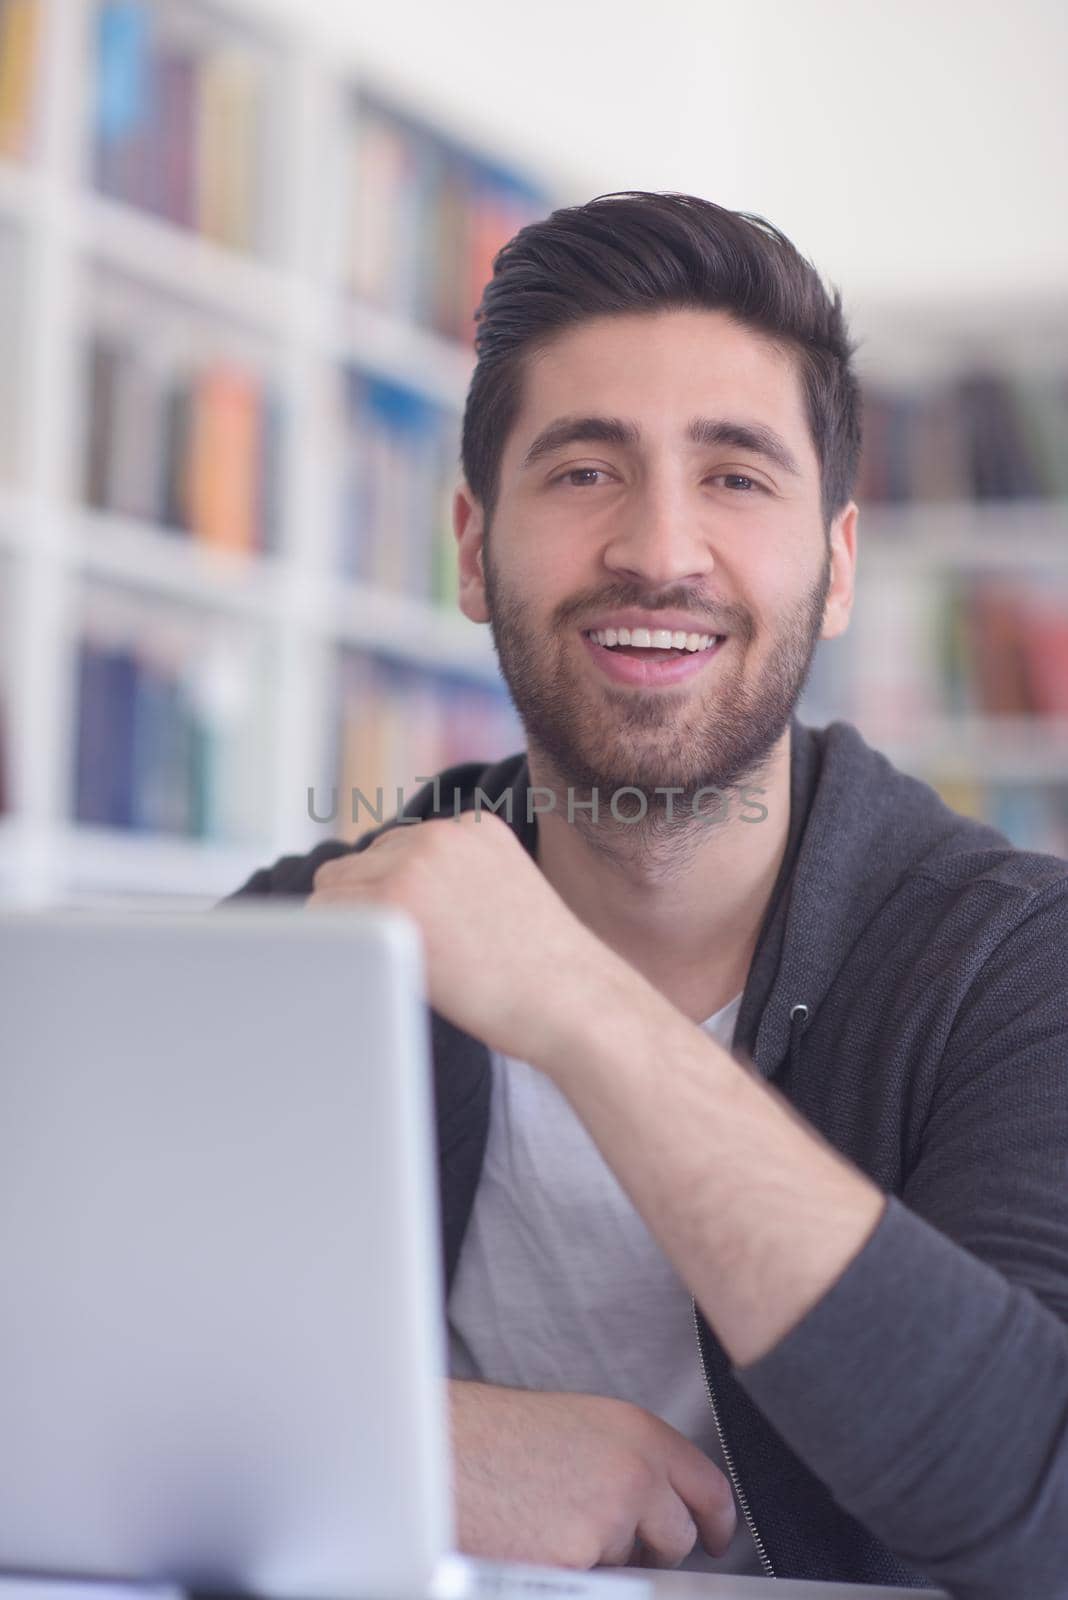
[0, 0, 548, 907]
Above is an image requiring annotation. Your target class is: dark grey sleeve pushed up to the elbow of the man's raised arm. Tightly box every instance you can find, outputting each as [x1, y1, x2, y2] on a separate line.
[734, 880, 1068, 1600]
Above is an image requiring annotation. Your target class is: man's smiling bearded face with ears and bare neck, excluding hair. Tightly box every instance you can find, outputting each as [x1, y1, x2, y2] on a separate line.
[456, 300, 857, 1022]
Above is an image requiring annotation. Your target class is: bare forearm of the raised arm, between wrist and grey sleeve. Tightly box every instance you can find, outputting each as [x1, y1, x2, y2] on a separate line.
[534, 963, 886, 1365]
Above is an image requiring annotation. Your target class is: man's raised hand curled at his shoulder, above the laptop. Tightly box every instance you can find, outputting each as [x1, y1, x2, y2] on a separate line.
[305, 811, 626, 1066]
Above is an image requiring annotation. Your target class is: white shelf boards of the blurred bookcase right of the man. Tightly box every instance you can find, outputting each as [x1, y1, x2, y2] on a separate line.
[799, 312, 1068, 856]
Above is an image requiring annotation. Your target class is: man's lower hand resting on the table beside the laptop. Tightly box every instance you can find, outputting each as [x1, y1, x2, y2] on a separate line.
[448, 1379, 737, 1568]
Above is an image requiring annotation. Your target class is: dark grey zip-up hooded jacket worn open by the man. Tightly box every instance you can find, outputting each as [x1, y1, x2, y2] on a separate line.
[222, 717, 1068, 1600]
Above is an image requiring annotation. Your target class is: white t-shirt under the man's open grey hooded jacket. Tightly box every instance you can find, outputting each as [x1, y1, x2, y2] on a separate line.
[448, 994, 764, 1574]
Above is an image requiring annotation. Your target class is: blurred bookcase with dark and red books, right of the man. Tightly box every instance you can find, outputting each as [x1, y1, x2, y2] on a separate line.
[798, 315, 1068, 858]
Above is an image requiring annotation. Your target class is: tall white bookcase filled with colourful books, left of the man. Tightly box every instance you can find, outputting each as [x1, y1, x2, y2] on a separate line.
[0, 0, 543, 909]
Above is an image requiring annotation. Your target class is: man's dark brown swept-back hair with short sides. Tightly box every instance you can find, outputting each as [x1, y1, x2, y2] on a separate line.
[460, 190, 860, 533]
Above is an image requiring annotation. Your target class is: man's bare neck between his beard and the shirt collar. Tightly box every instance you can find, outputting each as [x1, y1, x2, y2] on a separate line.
[528, 728, 790, 1022]
